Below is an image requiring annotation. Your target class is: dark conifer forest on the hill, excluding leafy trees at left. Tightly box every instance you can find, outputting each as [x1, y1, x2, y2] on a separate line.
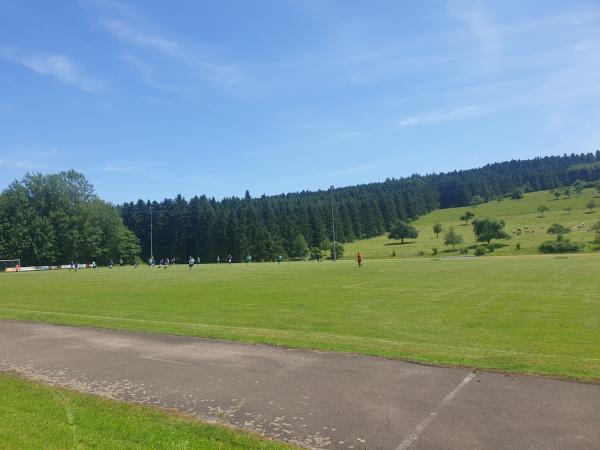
[120, 151, 600, 262]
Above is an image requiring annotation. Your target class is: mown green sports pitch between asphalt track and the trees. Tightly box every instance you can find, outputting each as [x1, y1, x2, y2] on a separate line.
[0, 254, 600, 381]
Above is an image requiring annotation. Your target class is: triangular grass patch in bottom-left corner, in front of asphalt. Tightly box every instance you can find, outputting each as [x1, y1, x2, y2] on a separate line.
[0, 374, 291, 450]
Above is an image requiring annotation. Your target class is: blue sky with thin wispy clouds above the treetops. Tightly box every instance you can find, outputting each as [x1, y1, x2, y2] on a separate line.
[0, 0, 600, 202]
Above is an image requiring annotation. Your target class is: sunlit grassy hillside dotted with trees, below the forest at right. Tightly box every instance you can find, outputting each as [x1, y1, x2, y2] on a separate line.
[344, 189, 600, 259]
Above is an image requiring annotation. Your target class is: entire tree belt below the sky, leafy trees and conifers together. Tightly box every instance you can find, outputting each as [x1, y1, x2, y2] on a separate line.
[0, 151, 600, 264]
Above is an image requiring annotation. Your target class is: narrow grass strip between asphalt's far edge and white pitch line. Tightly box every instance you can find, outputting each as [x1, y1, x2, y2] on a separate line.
[0, 308, 600, 384]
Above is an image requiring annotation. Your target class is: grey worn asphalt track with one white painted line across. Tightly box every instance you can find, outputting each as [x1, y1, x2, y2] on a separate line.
[0, 321, 600, 449]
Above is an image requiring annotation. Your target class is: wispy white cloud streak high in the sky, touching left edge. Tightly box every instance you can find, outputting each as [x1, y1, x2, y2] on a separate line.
[0, 48, 104, 92]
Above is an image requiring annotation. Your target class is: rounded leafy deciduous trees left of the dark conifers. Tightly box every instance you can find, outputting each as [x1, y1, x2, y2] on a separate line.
[0, 170, 140, 265]
